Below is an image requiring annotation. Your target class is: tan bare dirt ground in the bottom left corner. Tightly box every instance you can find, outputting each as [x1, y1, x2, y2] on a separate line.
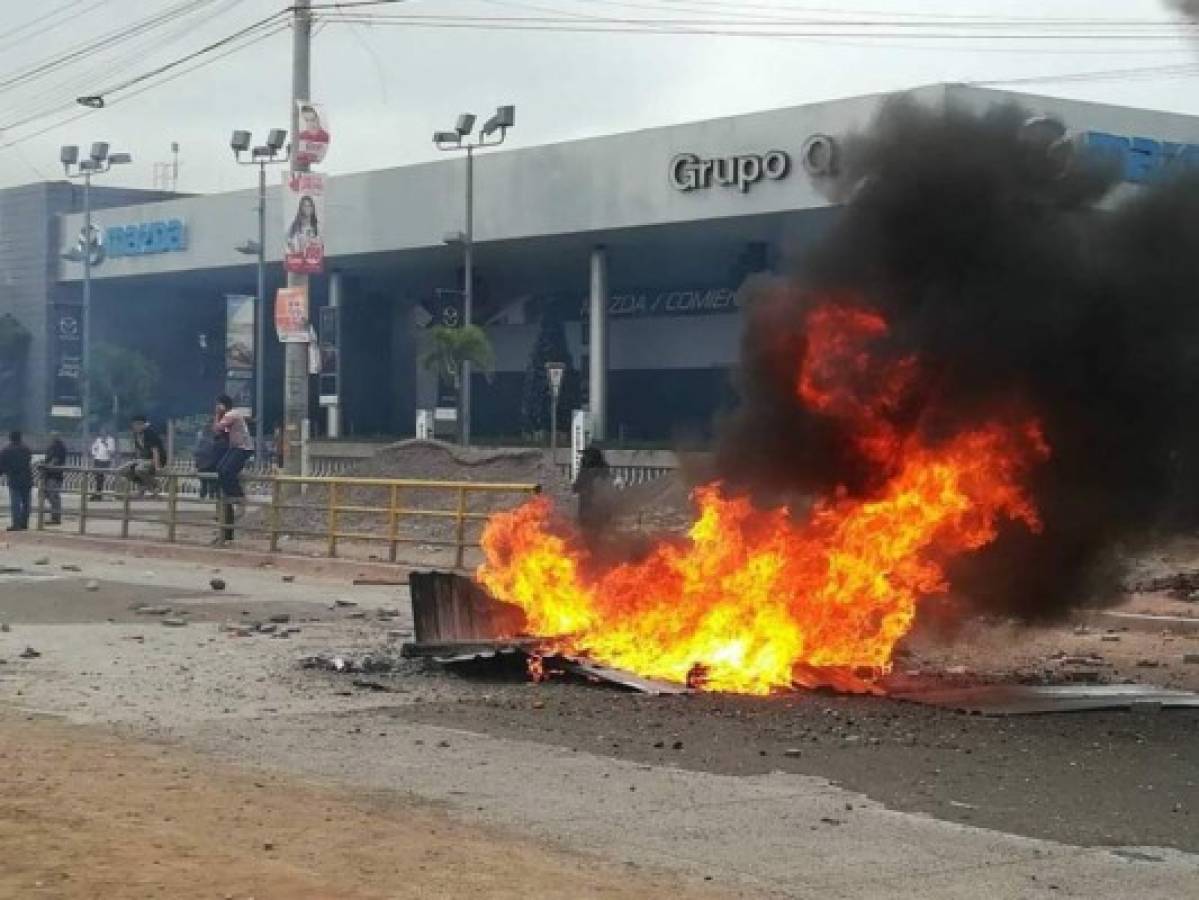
[0, 708, 717, 900]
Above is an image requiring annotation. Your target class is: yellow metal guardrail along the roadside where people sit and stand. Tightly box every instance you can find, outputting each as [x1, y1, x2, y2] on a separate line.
[26, 466, 541, 568]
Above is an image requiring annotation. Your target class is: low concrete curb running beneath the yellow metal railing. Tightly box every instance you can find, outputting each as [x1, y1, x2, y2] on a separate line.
[5, 531, 435, 585]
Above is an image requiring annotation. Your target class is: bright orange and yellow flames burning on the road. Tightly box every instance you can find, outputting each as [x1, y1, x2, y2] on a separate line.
[477, 303, 1049, 694]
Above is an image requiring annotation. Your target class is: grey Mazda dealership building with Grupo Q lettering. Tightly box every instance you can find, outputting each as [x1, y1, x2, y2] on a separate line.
[0, 85, 1199, 442]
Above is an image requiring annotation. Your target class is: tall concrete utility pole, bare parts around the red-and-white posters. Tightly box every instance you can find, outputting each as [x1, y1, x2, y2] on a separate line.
[283, 0, 312, 476]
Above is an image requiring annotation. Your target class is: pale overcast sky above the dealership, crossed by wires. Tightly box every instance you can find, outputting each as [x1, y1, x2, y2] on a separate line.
[0, 0, 1199, 192]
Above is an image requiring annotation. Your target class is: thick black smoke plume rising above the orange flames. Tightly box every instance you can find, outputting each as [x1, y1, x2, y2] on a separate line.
[717, 99, 1199, 617]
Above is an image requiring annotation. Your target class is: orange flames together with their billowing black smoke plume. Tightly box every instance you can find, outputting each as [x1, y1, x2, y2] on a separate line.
[477, 102, 1199, 694]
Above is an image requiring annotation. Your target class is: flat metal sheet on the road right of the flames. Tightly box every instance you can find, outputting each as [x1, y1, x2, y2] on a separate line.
[891, 684, 1199, 715]
